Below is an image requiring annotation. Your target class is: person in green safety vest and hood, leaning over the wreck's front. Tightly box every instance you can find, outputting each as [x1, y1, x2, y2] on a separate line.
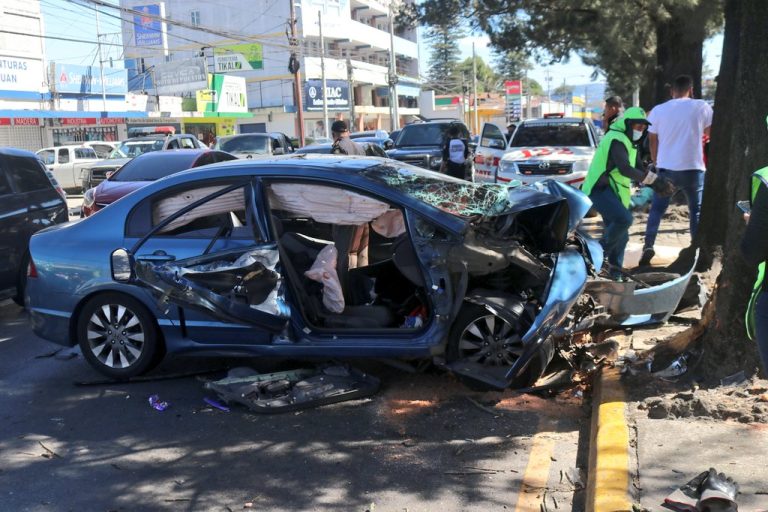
[581, 107, 674, 280]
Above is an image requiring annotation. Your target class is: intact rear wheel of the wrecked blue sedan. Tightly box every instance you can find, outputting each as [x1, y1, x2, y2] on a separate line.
[77, 293, 163, 380]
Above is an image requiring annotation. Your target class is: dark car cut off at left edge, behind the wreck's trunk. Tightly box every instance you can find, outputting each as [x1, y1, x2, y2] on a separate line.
[0, 148, 69, 304]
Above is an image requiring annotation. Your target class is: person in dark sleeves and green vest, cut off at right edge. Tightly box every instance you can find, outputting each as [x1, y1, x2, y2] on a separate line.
[741, 122, 768, 374]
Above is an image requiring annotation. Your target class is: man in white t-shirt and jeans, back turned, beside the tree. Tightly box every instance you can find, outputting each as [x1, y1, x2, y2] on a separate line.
[640, 75, 712, 266]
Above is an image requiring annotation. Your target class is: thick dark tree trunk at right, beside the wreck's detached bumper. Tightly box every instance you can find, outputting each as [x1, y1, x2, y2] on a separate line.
[697, 0, 768, 377]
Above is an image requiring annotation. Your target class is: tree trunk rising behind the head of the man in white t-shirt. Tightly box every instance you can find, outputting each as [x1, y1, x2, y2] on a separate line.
[654, 2, 708, 105]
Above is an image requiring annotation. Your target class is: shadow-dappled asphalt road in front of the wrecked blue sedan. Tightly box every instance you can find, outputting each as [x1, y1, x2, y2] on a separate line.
[0, 303, 589, 512]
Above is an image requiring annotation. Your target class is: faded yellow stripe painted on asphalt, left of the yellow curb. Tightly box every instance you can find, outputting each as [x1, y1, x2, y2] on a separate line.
[515, 419, 555, 512]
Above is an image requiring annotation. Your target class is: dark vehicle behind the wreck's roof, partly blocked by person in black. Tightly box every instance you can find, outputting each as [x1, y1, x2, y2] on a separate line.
[387, 120, 473, 178]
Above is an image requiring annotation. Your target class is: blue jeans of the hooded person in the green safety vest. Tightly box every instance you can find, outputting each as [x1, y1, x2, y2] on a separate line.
[589, 187, 632, 268]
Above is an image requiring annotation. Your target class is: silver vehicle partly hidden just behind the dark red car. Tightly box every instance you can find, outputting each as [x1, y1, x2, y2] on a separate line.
[81, 134, 206, 193]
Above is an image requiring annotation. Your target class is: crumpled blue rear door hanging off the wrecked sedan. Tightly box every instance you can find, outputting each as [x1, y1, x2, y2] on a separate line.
[131, 182, 290, 341]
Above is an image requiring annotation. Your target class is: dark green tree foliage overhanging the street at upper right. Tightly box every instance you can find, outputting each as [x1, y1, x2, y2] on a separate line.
[421, 0, 722, 106]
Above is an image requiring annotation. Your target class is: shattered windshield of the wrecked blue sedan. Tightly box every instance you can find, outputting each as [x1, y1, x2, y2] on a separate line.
[361, 163, 510, 217]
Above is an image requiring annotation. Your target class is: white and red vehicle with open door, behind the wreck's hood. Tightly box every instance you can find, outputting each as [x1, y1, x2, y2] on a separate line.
[475, 117, 599, 188]
